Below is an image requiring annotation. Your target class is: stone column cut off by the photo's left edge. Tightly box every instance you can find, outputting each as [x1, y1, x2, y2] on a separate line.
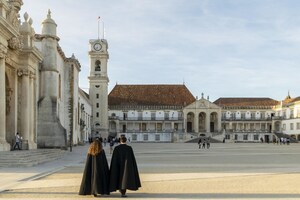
[0, 44, 10, 151]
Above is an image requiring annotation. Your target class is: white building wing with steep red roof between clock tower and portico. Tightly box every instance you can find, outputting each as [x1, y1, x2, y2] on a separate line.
[108, 85, 195, 142]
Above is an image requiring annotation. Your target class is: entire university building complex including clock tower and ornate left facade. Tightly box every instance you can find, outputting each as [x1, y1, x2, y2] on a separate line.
[0, 0, 300, 151]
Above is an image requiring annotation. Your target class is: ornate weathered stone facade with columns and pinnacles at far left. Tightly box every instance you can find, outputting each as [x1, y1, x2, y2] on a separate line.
[0, 0, 83, 151]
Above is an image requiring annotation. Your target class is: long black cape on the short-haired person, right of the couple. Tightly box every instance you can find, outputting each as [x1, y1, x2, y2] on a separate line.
[109, 144, 141, 192]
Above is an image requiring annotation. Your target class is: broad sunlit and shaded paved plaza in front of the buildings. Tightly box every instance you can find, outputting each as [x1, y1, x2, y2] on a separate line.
[0, 143, 300, 200]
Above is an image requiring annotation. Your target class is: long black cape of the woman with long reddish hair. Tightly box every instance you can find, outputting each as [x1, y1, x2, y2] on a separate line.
[79, 150, 109, 195]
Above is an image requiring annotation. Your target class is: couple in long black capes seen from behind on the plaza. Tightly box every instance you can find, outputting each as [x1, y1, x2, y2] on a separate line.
[79, 135, 141, 197]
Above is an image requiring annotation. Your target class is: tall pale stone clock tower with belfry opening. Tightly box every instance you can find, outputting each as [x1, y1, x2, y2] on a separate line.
[88, 39, 109, 138]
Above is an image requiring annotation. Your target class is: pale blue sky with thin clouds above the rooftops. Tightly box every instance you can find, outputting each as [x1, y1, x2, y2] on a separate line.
[20, 0, 300, 101]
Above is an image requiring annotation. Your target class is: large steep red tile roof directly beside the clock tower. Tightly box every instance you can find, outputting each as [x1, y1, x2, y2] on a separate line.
[108, 85, 196, 106]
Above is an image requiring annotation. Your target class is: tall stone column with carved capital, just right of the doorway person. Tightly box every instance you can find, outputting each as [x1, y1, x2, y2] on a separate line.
[18, 70, 31, 149]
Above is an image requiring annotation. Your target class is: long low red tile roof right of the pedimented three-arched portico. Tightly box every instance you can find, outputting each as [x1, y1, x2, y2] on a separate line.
[214, 98, 279, 108]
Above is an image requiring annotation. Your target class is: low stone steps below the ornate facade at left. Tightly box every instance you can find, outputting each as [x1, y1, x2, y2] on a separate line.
[0, 149, 66, 167]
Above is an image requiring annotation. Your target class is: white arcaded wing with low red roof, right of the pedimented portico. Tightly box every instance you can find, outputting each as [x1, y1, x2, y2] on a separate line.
[214, 98, 278, 142]
